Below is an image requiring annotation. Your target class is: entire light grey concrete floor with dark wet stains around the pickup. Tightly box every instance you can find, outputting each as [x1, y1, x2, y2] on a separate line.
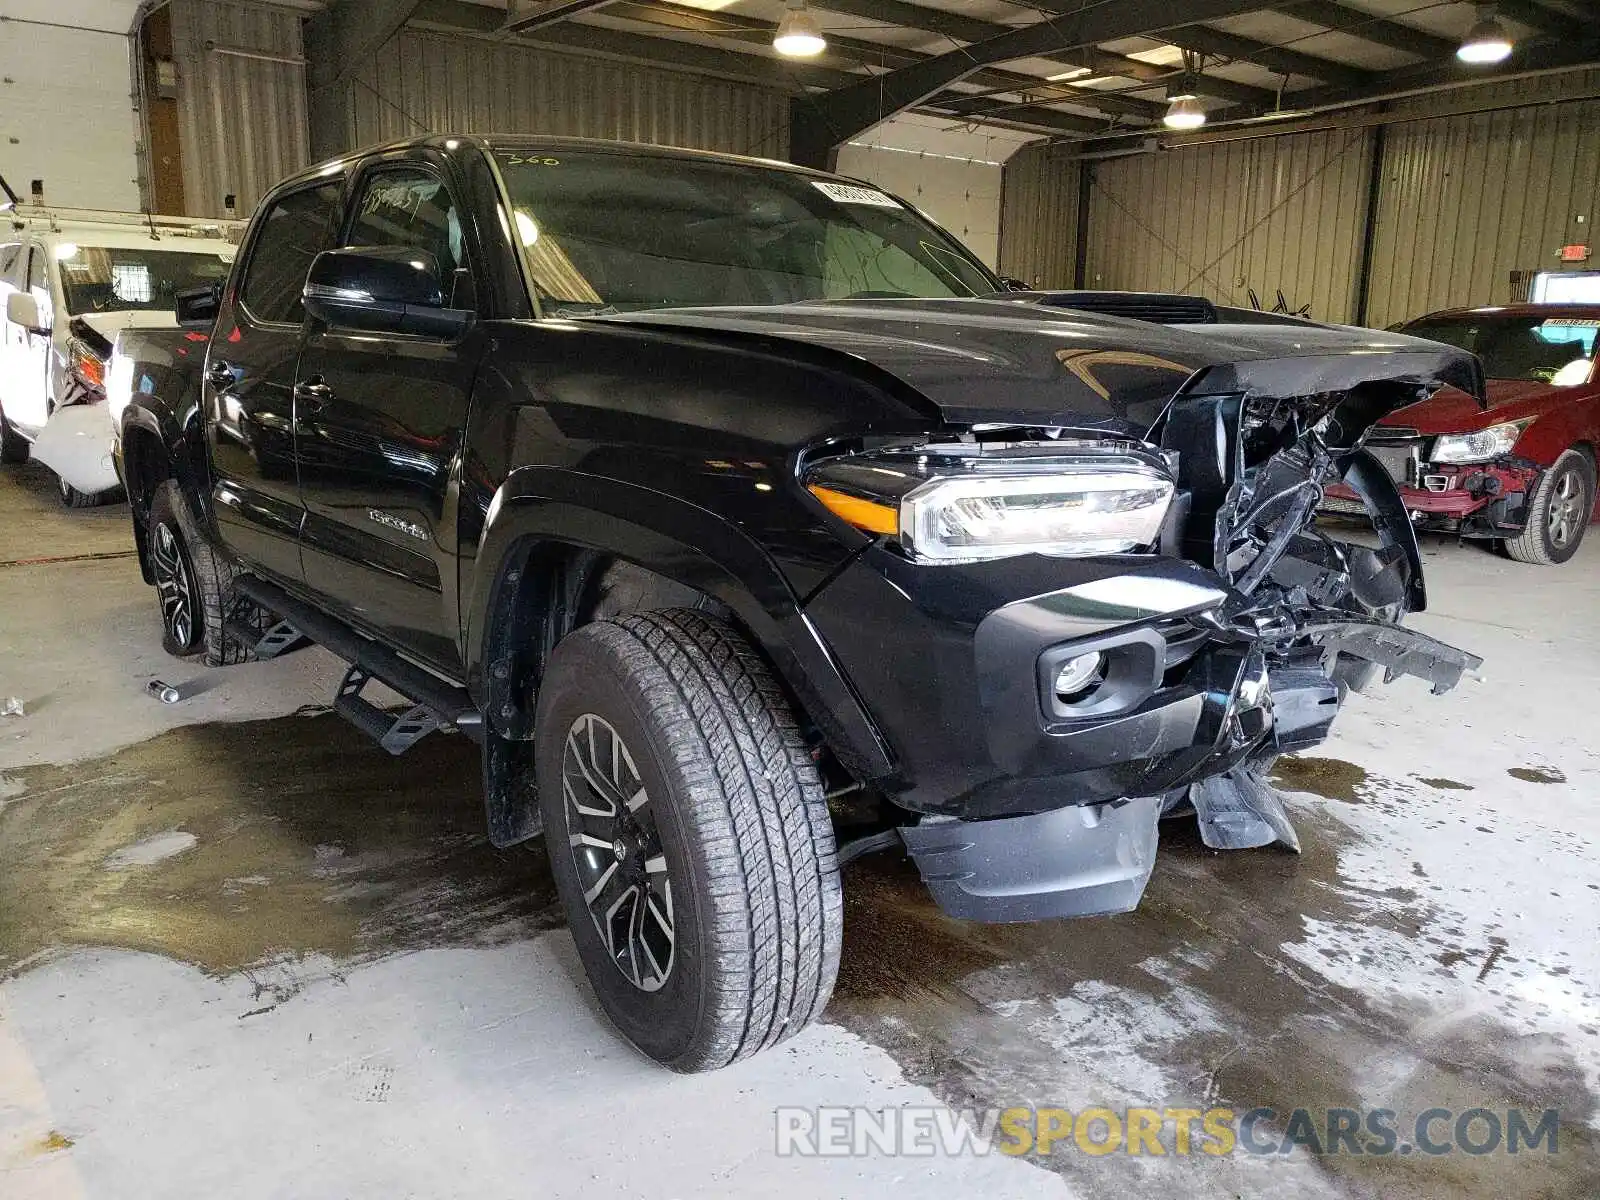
[0, 454, 1600, 1200]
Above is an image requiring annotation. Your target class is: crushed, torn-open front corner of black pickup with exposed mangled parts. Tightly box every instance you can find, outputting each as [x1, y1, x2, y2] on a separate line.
[1152, 382, 1482, 850]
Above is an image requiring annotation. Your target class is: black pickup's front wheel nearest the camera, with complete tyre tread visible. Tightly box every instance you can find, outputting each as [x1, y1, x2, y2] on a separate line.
[534, 610, 843, 1072]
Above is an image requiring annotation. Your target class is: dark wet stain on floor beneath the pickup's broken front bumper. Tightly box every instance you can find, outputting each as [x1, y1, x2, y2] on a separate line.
[827, 806, 1600, 1200]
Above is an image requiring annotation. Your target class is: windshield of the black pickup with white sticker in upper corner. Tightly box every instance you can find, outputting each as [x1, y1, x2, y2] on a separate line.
[496, 150, 1000, 315]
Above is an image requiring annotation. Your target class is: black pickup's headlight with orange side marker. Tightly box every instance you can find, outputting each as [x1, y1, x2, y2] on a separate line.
[805, 445, 1176, 563]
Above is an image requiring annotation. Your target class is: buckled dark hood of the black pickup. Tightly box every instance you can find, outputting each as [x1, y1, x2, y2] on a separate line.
[592, 294, 1483, 437]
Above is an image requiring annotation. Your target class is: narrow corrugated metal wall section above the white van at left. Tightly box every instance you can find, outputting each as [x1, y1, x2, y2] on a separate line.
[171, 0, 310, 216]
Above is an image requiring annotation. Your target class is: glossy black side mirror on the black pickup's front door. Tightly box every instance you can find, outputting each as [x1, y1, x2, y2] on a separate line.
[304, 246, 472, 338]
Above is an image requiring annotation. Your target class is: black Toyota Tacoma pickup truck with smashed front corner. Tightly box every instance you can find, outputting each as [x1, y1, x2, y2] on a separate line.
[112, 136, 1483, 1070]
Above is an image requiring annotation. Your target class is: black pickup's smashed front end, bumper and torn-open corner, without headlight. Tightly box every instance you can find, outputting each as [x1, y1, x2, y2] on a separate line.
[825, 329, 1480, 922]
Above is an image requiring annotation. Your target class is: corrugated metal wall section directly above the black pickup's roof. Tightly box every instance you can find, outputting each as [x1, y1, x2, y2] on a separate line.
[340, 29, 789, 158]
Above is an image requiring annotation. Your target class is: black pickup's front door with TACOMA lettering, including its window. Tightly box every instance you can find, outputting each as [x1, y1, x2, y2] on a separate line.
[294, 152, 483, 672]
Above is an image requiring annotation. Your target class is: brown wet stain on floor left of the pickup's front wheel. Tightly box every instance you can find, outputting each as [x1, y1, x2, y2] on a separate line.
[0, 715, 560, 985]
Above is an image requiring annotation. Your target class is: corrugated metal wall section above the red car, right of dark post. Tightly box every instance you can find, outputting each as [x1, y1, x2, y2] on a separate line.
[1368, 88, 1600, 326]
